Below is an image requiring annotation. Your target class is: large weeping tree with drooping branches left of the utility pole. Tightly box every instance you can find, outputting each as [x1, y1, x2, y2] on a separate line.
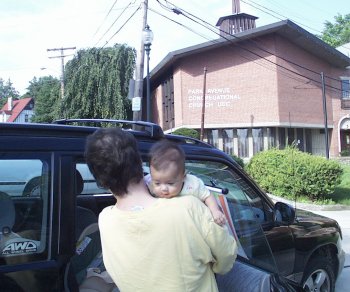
[61, 44, 136, 119]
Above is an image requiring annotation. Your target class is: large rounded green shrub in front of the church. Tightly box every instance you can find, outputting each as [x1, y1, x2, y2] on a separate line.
[246, 147, 343, 200]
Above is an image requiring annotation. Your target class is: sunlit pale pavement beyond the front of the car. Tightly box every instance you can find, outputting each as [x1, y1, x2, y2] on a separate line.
[269, 195, 350, 292]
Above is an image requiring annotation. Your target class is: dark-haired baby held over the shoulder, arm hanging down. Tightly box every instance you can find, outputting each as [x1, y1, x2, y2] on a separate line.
[145, 140, 226, 226]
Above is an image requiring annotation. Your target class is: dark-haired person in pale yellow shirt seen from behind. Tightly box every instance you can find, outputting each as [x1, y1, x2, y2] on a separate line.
[86, 128, 237, 292]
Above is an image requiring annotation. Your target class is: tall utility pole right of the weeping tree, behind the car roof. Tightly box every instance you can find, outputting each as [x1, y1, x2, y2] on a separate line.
[132, 0, 148, 121]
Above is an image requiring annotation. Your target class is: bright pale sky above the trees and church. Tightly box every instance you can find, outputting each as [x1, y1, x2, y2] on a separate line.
[0, 0, 350, 94]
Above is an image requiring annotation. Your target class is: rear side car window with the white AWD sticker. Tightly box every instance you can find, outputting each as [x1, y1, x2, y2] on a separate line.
[0, 153, 51, 264]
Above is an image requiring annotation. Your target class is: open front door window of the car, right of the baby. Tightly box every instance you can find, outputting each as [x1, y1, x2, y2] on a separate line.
[186, 160, 277, 272]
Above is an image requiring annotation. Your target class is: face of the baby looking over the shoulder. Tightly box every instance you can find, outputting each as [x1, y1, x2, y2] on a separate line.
[150, 163, 185, 199]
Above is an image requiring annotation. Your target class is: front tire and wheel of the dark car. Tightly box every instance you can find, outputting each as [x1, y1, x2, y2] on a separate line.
[302, 258, 335, 292]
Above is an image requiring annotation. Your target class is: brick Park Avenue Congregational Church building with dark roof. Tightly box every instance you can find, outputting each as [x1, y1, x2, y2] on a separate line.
[143, 13, 350, 158]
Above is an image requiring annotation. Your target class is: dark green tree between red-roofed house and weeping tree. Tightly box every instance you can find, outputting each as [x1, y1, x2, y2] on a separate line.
[26, 76, 61, 123]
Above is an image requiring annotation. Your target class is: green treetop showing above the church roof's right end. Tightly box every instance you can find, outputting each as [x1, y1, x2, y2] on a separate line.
[319, 14, 350, 47]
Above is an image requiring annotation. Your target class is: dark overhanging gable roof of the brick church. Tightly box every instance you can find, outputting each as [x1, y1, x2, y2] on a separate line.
[150, 19, 350, 84]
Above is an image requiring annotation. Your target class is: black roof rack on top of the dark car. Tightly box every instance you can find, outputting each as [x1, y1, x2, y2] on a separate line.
[52, 119, 164, 138]
